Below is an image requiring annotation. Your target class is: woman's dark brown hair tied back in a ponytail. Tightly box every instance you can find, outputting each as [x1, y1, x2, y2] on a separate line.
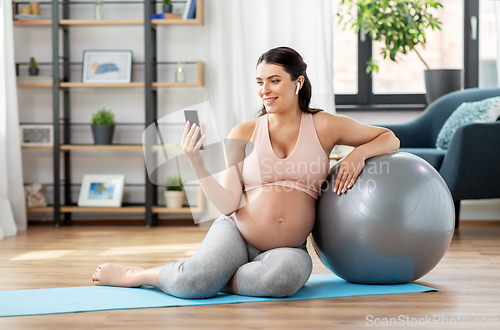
[257, 47, 323, 117]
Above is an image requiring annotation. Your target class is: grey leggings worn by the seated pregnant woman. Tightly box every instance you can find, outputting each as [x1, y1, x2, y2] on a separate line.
[160, 215, 312, 298]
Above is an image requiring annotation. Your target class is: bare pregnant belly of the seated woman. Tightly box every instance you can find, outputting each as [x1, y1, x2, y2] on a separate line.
[233, 185, 316, 251]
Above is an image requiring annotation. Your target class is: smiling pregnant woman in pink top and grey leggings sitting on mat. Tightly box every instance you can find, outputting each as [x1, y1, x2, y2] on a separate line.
[92, 47, 399, 298]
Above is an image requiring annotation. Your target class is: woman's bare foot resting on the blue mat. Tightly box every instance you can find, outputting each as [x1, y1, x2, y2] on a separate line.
[92, 263, 145, 288]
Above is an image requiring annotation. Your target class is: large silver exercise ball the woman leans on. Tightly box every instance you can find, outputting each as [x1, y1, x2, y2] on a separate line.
[312, 152, 455, 284]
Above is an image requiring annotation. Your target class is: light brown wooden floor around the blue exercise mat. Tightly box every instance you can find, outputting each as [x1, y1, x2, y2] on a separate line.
[0, 222, 500, 330]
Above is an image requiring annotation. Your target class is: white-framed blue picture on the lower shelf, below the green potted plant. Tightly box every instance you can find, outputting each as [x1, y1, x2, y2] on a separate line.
[78, 174, 125, 207]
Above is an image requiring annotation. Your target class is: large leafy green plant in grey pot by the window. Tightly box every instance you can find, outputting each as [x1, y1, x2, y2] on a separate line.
[337, 0, 462, 103]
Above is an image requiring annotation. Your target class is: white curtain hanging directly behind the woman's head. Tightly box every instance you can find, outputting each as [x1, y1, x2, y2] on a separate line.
[205, 0, 335, 138]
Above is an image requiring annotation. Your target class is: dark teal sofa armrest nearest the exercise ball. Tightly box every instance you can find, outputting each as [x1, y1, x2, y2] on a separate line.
[439, 121, 500, 200]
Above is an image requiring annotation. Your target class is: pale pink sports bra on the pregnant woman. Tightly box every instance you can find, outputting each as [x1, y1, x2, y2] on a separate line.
[242, 112, 330, 199]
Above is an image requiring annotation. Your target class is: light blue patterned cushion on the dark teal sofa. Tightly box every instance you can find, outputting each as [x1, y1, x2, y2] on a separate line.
[436, 96, 500, 149]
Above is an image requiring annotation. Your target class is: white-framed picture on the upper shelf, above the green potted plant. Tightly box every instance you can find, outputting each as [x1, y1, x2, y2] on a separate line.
[82, 50, 132, 84]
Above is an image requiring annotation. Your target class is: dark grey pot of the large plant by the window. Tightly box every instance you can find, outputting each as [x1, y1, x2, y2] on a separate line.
[424, 69, 463, 104]
